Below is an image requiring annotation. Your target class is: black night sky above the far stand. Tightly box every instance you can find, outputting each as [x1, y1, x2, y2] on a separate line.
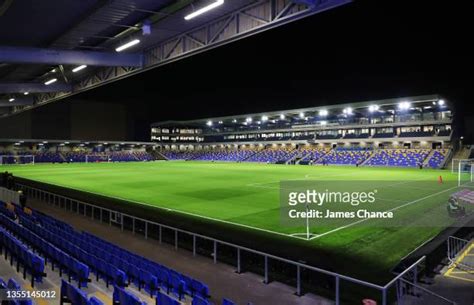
[76, 0, 474, 139]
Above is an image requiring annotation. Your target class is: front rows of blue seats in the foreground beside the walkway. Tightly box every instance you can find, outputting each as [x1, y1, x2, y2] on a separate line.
[0, 202, 209, 299]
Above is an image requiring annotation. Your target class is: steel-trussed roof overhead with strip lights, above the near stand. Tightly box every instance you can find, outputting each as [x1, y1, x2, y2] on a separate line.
[0, 0, 350, 116]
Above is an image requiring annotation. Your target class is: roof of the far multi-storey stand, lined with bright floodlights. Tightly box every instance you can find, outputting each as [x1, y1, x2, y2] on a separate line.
[152, 94, 445, 127]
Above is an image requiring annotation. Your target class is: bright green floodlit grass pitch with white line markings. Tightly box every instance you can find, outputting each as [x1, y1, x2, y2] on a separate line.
[2, 161, 466, 280]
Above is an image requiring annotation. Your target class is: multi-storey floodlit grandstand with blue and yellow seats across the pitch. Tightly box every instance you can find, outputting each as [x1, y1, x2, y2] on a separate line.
[151, 95, 453, 168]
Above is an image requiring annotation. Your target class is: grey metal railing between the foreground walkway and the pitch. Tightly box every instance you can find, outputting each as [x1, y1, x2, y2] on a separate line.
[17, 184, 440, 305]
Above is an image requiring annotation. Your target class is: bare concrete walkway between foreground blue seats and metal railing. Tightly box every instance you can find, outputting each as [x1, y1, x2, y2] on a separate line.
[29, 200, 334, 305]
